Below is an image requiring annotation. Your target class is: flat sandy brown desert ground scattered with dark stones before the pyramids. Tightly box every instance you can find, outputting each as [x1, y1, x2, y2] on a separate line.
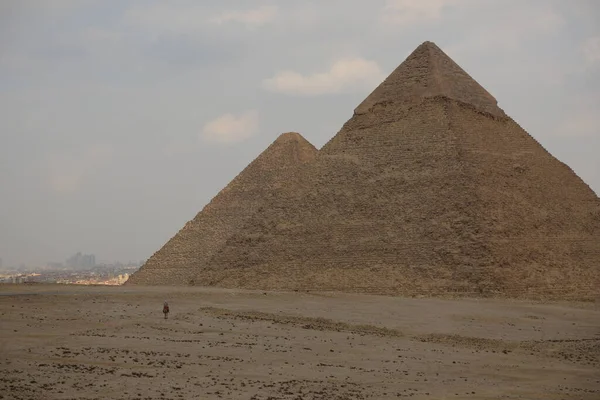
[0, 285, 600, 400]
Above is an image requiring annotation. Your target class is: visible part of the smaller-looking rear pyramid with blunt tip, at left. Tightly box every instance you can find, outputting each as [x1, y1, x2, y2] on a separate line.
[127, 132, 317, 285]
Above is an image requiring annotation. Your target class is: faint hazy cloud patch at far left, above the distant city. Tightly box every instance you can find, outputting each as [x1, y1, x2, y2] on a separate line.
[46, 145, 113, 194]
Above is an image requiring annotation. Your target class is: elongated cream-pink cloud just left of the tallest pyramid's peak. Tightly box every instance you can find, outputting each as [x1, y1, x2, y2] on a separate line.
[263, 58, 385, 96]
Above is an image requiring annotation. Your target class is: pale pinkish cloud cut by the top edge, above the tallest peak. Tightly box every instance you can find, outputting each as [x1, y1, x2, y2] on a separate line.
[382, 0, 466, 25]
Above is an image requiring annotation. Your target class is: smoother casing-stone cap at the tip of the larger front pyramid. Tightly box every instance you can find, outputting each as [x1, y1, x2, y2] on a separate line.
[354, 41, 506, 117]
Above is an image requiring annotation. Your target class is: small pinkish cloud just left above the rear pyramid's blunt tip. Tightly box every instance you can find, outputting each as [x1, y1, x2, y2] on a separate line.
[202, 110, 258, 144]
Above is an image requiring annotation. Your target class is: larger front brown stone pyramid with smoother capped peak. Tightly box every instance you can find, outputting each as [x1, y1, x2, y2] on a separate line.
[196, 42, 600, 298]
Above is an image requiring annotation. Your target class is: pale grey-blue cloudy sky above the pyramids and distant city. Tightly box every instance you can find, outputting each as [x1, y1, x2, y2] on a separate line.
[0, 0, 600, 266]
